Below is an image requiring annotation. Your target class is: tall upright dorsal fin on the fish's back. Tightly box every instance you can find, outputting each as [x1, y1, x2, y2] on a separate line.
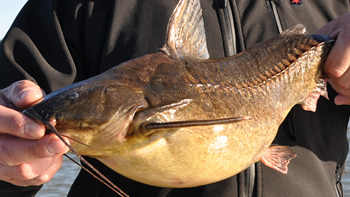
[160, 0, 209, 59]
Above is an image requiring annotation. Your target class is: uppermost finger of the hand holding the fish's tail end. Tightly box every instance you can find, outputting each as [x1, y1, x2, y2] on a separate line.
[324, 25, 350, 78]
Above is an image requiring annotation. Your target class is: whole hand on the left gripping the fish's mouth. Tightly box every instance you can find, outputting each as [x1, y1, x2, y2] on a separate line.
[0, 80, 68, 186]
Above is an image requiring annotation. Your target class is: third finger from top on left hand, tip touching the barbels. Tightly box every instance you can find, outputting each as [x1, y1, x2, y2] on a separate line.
[0, 134, 68, 166]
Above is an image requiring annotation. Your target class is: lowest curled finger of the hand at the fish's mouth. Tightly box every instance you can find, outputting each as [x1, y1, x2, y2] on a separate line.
[0, 155, 63, 186]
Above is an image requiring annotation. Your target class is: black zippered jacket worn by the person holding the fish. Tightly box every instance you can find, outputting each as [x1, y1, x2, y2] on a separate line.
[0, 0, 350, 197]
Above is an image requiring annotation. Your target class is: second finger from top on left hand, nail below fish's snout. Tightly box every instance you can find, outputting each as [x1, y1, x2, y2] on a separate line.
[0, 105, 45, 139]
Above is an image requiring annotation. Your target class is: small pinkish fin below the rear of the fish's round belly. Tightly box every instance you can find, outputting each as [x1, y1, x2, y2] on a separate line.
[260, 146, 297, 174]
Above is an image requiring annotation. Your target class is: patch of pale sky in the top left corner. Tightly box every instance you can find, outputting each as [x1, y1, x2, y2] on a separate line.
[0, 0, 27, 40]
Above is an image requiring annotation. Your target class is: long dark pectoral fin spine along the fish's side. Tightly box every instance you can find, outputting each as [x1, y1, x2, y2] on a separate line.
[142, 116, 251, 130]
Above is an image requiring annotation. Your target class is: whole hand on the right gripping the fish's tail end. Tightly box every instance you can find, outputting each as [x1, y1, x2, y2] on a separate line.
[318, 13, 350, 105]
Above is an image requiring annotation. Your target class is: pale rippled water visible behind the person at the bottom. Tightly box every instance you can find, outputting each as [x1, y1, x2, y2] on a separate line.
[36, 135, 350, 197]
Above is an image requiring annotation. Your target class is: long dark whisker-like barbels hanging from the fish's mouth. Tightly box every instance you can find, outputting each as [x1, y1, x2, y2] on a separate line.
[44, 122, 129, 197]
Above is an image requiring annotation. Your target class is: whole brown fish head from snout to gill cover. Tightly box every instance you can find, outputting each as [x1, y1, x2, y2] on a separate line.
[23, 77, 147, 155]
